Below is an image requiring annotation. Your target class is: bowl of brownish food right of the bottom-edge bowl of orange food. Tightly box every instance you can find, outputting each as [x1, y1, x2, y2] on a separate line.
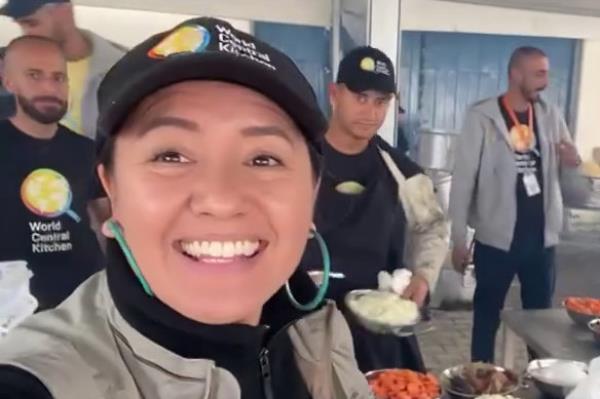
[440, 363, 521, 399]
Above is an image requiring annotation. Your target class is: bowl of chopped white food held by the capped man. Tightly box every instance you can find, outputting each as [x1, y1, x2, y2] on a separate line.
[345, 290, 421, 337]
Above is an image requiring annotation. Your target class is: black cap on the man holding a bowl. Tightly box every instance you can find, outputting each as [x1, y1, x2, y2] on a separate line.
[337, 46, 396, 93]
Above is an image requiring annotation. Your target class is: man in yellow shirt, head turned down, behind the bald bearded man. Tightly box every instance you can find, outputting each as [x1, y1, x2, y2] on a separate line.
[0, 0, 124, 139]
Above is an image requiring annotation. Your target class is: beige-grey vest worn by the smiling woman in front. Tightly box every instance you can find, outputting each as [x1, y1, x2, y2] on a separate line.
[0, 272, 372, 399]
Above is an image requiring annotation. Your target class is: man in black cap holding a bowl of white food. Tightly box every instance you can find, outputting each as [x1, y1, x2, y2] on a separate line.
[303, 47, 448, 371]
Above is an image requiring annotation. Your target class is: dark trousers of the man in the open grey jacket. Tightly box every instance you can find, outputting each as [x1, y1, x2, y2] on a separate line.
[471, 242, 556, 363]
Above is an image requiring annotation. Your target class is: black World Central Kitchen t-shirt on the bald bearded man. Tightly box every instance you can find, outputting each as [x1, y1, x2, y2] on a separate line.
[0, 120, 103, 309]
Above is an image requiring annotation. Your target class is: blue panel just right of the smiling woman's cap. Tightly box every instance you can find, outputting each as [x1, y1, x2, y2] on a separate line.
[254, 22, 331, 112]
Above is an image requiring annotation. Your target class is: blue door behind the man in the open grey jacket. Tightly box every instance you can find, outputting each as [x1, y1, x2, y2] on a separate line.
[400, 31, 577, 147]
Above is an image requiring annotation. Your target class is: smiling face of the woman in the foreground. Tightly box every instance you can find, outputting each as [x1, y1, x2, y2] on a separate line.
[101, 81, 316, 324]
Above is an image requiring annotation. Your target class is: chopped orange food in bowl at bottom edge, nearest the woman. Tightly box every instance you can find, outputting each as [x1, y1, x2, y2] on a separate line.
[366, 369, 441, 399]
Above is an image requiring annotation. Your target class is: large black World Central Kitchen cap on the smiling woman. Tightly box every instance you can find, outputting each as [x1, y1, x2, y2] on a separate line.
[97, 17, 327, 153]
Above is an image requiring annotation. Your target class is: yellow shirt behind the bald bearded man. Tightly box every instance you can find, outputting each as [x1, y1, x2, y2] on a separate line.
[61, 57, 90, 134]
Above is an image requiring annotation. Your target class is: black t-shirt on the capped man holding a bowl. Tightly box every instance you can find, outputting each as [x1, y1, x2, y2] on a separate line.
[302, 137, 420, 303]
